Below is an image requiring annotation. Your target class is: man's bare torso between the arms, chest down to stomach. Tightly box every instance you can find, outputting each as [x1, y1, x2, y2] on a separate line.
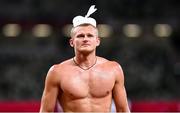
[60, 66, 114, 111]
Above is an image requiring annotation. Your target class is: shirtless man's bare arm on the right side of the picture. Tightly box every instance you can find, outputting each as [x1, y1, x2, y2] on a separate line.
[113, 63, 130, 112]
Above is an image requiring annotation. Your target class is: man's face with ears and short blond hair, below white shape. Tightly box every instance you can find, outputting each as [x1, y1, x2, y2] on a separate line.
[70, 25, 100, 53]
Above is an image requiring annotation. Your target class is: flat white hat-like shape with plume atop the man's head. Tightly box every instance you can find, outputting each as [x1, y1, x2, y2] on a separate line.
[73, 5, 97, 27]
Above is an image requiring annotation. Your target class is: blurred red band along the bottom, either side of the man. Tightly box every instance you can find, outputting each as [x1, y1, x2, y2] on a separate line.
[0, 101, 180, 112]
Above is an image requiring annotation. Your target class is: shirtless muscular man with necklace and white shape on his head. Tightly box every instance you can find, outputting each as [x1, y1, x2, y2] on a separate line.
[40, 6, 129, 112]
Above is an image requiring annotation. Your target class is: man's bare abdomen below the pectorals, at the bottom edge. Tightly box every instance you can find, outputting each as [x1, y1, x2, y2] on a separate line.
[60, 95, 111, 112]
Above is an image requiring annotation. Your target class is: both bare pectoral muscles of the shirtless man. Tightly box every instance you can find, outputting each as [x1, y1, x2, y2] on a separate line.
[61, 70, 115, 98]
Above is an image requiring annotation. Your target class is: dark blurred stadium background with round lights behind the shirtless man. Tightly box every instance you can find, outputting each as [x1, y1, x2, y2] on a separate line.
[0, 0, 180, 112]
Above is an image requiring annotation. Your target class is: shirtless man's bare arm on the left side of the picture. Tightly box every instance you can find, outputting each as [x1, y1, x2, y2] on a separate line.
[40, 66, 59, 112]
